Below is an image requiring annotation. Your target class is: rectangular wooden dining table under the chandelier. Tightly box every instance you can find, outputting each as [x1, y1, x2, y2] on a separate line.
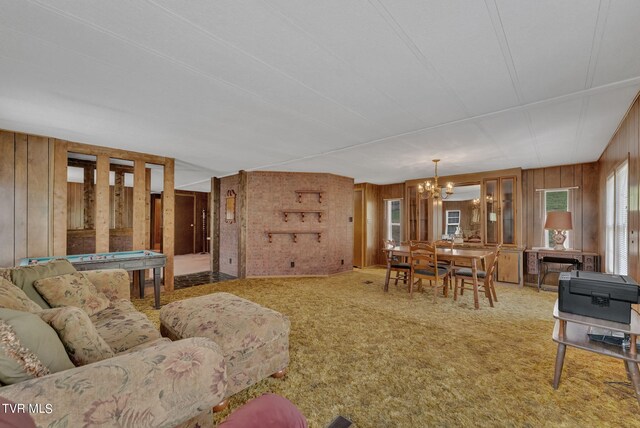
[382, 245, 494, 309]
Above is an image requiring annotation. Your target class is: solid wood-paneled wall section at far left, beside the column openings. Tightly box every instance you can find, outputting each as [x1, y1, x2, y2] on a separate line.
[0, 131, 55, 266]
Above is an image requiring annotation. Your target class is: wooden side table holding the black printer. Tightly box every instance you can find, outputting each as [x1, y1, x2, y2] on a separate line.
[553, 300, 640, 404]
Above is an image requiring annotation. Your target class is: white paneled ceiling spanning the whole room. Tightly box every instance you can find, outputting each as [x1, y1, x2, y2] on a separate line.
[0, 0, 640, 190]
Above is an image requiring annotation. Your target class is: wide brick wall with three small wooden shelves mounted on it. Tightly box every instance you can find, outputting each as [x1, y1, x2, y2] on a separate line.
[244, 172, 353, 276]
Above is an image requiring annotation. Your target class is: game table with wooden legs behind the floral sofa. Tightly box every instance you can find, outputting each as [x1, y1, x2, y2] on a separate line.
[20, 250, 167, 309]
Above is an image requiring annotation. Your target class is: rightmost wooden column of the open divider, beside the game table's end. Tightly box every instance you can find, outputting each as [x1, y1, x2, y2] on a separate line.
[162, 159, 176, 292]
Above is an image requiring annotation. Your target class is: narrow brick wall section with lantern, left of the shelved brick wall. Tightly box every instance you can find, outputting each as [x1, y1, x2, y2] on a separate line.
[219, 175, 238, 276]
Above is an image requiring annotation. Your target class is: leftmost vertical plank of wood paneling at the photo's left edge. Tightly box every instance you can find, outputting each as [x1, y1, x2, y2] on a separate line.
[0, 131, 15, 266]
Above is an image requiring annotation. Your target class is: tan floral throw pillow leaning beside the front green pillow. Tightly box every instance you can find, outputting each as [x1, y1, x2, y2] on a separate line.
[38, 306, 115, 366]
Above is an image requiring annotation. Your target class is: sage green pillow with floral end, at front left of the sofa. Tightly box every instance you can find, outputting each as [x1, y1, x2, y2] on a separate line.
[0, 309, 74, 385]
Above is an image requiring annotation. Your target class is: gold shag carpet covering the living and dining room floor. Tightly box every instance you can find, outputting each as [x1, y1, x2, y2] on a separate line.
[134, 269, 640, 427]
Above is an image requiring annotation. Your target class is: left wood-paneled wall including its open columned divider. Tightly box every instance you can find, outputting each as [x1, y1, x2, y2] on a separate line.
[0, 130, 174, 291]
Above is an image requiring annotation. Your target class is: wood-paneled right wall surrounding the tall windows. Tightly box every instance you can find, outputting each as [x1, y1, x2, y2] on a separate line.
[598, 97, 640, 281]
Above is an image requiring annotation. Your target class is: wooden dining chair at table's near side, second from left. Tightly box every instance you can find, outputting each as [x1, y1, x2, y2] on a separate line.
[409, 242, 451, 303]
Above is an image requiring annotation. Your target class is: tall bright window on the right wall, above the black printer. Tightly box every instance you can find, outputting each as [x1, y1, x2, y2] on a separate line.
[605, 161, 629, 275]
